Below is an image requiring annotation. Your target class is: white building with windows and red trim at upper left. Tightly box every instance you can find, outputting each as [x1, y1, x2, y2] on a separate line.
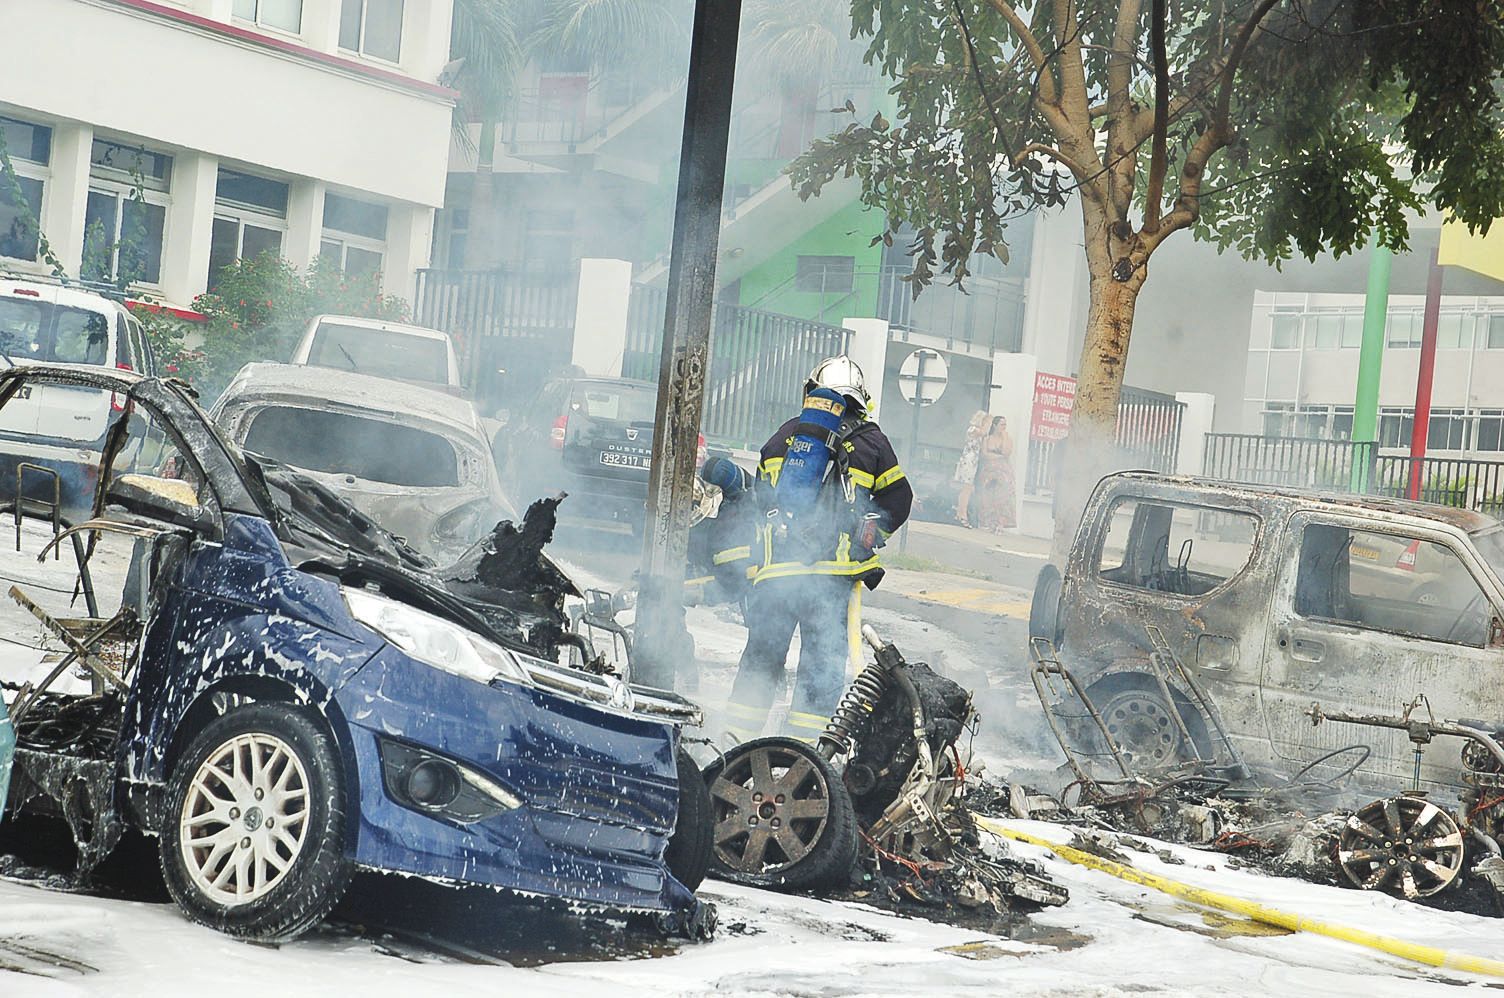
[0, 0, 454, 305]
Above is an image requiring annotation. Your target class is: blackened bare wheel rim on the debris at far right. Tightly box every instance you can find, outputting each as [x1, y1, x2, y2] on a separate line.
[1337, 797, 1463, 899]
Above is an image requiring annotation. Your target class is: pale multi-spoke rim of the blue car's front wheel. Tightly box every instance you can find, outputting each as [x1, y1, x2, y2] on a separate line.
[177, 733, 308, 908]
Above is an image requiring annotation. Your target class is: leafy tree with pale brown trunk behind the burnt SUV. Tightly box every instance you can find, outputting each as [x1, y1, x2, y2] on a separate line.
[790, 0, 1504, 553]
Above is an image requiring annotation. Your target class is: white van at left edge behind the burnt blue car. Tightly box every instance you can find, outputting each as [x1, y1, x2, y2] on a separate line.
[0, 277, 156, 516]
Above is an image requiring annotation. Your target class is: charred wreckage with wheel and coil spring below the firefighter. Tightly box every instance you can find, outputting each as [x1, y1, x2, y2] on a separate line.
[705, 627, 1068, 920]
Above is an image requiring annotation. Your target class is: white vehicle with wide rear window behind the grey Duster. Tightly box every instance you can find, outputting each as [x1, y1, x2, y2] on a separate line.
[292, 316, 462, 392]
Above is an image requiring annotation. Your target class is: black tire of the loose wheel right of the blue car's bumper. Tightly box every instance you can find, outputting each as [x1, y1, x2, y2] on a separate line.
[705, 738, 857, 890]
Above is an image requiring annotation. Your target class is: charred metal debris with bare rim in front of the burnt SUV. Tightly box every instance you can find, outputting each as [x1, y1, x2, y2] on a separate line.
[1028, 625, 1504, 915]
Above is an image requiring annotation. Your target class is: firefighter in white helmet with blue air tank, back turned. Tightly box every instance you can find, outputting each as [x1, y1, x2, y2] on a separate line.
[726, 356, 914, 741]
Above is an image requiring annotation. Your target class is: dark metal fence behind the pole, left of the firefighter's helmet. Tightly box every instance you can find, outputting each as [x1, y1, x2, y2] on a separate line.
[621, 284, 851, 448]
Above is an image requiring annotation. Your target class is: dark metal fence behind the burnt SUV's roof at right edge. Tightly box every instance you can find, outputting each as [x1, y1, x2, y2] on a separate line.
[1202, 433, 1504, 516]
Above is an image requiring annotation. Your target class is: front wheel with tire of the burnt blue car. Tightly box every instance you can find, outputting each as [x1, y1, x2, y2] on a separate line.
[159, 702, 352, 942]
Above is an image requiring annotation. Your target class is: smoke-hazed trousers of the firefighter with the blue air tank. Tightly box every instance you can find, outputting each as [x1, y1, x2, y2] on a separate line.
[726, 576, 862, 741]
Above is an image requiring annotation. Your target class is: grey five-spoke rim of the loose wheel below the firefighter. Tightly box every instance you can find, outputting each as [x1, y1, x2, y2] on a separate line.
[710, 745, 830, 875]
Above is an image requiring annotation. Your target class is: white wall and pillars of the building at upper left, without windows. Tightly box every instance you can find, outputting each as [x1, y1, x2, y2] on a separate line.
[0, 0, 453, 305]
